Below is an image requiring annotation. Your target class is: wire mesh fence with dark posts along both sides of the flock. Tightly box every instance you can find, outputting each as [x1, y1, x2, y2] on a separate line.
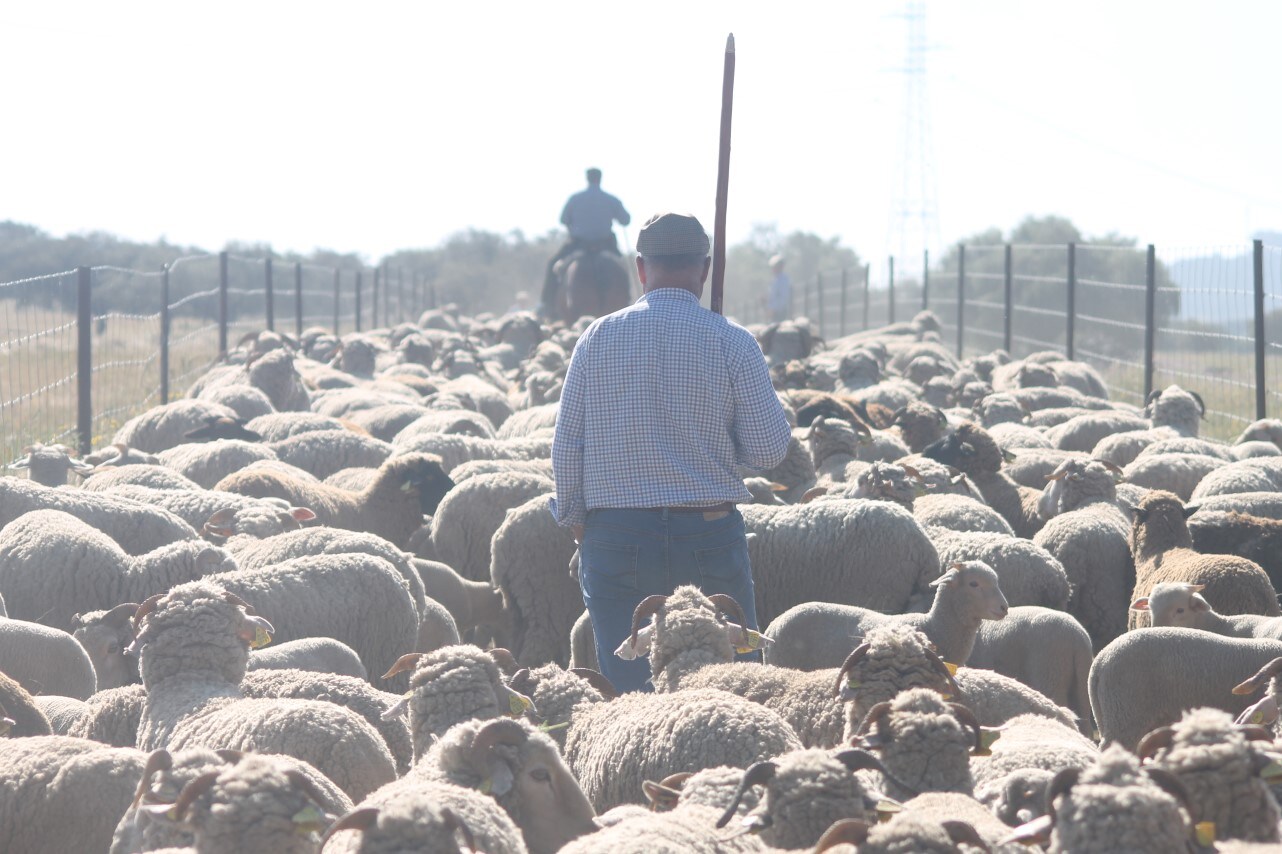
[0, 235, 1282, 462]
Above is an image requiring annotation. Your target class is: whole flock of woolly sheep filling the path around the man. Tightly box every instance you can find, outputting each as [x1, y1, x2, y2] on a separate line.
[0, 308, 1282, 854]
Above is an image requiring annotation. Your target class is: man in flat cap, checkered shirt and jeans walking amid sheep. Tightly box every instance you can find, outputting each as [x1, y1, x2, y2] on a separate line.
[551, 213, 792, 691]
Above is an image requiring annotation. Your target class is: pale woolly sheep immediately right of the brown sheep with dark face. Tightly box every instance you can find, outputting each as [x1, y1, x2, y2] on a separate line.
[432, 472, 556, 581]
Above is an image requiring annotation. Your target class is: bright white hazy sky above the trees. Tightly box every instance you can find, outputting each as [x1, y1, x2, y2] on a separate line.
[0, 0, 1282, 260]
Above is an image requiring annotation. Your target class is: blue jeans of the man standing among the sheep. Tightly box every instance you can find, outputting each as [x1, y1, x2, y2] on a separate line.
[578, 510, 760, 691]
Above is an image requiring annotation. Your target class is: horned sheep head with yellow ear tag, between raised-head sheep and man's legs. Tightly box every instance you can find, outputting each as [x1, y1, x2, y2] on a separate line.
[374, 644, 531, 760]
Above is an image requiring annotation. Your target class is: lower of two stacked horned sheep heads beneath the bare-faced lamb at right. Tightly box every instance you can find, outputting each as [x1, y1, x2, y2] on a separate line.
[853, 689, 982, 800]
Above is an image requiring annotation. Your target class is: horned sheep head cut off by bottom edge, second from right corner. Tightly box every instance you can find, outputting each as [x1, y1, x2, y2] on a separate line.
[1010, 746, 1192, 854]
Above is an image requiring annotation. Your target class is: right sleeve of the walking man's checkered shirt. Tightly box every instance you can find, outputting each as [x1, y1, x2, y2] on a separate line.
[731, 332, 792, 469]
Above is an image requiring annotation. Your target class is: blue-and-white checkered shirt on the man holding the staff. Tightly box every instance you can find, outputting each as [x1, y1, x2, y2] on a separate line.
[553, 287, 792, 526]
